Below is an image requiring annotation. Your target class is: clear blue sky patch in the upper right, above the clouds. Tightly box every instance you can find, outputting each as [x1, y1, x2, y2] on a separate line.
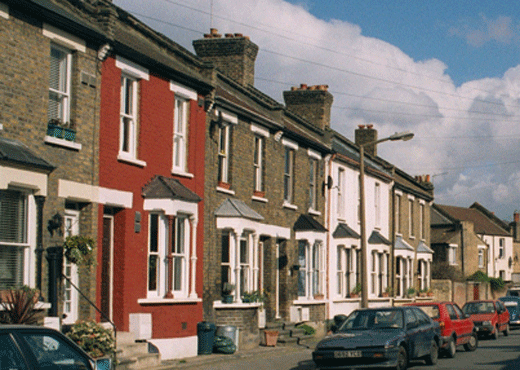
[289, 0, 520, 85]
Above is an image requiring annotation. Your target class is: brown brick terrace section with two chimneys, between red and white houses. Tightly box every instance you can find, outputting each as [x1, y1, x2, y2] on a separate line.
[193, 30, 332, 348]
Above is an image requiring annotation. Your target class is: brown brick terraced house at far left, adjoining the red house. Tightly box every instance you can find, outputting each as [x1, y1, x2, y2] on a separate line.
[0, 0, 106, 323]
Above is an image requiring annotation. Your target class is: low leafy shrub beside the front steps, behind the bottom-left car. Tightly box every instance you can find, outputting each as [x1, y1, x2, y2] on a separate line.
[66, 321, 116, 358]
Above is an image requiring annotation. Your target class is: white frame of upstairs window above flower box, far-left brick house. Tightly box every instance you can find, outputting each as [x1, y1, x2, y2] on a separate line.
[47, 43, 72, 123]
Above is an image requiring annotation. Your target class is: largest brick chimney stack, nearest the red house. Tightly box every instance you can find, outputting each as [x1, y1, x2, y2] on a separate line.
[193, 28, 258, 86]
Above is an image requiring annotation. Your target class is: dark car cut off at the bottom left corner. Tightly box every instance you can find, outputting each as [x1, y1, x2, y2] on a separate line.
[0, 325, 108, 370]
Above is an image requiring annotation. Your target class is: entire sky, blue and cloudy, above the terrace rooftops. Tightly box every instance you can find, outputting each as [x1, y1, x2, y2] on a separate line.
[113, 0, 520, 221]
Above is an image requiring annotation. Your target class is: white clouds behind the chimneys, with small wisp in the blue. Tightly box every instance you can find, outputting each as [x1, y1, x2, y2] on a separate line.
[114, 0, 520, 218]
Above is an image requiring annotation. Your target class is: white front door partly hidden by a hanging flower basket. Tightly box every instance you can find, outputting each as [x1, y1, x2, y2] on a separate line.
[63, 210, 79, 324]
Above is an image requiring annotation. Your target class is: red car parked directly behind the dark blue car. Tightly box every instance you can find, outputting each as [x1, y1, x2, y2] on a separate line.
[407, 302, 478, 358]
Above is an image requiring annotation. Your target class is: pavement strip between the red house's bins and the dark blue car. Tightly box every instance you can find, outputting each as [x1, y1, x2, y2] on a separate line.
[161, 339, 318, 370]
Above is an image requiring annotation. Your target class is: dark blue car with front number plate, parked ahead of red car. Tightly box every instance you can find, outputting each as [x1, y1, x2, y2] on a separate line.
[312, 307, 440, 370]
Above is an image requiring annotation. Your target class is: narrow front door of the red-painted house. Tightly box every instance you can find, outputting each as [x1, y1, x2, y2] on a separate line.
[101, 215, 114, 321]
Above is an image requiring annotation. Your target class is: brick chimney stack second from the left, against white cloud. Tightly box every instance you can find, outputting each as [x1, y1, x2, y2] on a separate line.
[283, 84, 334, 130]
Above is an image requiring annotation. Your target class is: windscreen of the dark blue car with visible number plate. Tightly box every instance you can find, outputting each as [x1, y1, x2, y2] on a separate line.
[339, 310, 403, 332]
